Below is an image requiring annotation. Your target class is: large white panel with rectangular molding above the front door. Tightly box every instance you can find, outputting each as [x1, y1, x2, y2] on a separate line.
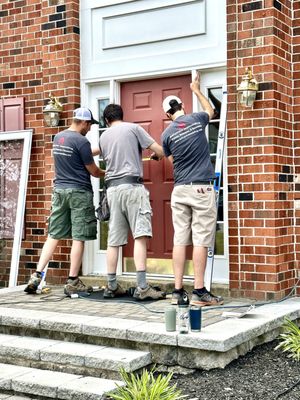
[81, 0, 226, 80]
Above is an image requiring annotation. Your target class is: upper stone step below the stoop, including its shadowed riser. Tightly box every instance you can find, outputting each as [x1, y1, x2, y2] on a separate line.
[0, 334, 151, 378]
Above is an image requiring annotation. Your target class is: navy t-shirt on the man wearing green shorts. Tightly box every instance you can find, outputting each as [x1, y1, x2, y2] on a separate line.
[53, 129, 94, 191]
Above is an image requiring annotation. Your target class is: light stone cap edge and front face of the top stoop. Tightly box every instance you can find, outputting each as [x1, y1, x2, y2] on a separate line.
[0, 298, 300, 370]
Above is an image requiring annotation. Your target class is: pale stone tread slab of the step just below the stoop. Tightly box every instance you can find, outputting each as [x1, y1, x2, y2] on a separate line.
[0, 334, 151, 372]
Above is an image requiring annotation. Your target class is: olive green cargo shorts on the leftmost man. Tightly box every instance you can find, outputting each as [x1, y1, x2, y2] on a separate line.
[48, 189, 97, 241]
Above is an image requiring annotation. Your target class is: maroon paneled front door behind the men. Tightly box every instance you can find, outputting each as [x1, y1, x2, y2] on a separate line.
[121, 75, 192, 270]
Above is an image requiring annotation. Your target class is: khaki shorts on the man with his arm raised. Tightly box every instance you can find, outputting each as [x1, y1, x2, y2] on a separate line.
[171, 185, 217, 247]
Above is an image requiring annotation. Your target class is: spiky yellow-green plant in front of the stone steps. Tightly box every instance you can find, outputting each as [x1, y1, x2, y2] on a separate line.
[109, 368, 186, 400]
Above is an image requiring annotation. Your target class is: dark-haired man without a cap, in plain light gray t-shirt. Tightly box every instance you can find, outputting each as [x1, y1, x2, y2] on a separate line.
[99, 104, 166, 300]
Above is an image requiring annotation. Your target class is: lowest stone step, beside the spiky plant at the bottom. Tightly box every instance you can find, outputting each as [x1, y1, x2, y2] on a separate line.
[0, 363, 124, 400]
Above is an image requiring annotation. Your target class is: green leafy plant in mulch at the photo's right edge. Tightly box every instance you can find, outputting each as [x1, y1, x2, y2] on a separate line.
[275, 319, 300, 361]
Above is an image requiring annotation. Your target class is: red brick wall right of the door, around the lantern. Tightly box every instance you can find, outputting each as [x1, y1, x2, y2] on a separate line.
[227, 0, 299, 300]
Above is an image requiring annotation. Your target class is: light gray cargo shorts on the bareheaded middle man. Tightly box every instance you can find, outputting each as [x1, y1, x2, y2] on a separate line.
[107, 184, 152, 246]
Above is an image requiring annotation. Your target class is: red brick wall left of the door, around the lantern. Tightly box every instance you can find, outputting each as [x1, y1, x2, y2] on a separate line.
[0, 0, 80, 286]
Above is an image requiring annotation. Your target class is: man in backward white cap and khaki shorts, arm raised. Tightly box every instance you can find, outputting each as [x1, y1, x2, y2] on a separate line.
[162, 74, 223, 306]
